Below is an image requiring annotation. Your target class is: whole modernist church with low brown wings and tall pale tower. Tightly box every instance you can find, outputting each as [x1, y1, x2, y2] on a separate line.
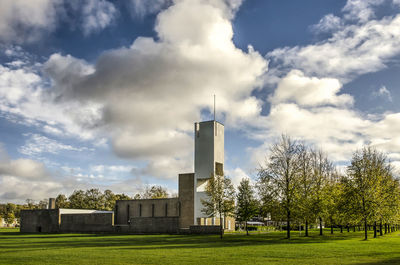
[20, 120, 235, 234]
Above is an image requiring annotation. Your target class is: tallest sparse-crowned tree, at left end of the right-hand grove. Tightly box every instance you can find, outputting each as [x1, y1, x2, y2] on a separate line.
[258, 135, 300, 239]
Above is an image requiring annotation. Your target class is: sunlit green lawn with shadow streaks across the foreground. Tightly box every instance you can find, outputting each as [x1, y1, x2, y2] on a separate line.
[0, 226, 400, 265]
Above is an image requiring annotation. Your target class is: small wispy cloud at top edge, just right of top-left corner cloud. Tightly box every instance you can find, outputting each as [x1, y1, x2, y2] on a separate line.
[82, 0, 117, 35]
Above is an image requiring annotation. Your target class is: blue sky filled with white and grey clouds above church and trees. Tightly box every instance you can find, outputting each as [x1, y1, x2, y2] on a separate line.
[0, 0, 400, 203]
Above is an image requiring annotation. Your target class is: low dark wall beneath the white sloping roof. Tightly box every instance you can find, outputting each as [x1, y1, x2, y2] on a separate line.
[60, 213, 114, 233]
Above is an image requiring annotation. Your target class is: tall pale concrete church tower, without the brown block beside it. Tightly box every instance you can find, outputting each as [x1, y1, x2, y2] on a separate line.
[194, 120, 224, 224]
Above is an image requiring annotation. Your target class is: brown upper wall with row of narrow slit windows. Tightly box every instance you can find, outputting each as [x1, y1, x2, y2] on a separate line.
[115, 198, 180, 225]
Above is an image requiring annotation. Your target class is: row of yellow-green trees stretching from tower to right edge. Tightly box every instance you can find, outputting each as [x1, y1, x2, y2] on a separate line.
[203, 135, 400, 239]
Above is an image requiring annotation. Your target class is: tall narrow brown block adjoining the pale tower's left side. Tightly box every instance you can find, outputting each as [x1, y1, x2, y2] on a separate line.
[179, 173, 194, 228]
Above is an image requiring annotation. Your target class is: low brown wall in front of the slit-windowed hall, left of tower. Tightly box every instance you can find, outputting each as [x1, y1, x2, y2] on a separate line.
[129, 217, 179, 234]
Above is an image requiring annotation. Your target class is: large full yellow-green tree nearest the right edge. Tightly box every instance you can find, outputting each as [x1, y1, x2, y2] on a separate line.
[345, 146, 392, 240]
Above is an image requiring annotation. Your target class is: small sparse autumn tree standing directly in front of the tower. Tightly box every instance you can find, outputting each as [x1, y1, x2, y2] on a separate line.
[201, 175, 235, 239]
